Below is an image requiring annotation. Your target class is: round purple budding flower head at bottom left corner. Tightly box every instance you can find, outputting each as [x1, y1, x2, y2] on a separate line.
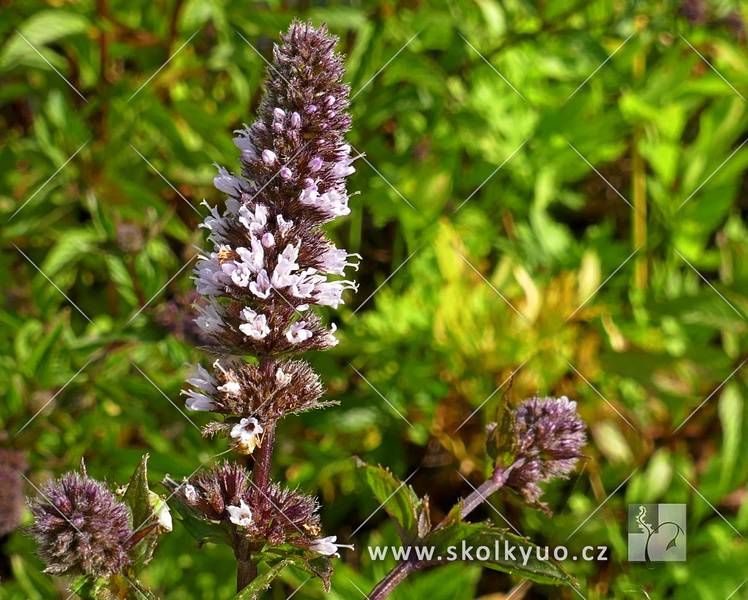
[29, 468, 133, 578]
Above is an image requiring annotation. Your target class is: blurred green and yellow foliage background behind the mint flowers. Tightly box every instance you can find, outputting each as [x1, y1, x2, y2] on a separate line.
[0, 0, 748, 600]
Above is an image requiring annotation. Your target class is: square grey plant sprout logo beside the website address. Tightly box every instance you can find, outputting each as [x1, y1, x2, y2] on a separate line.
[628, 504, 686, 569]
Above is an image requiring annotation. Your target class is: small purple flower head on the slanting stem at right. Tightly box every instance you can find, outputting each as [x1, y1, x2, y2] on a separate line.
[506, 396, 587, 504]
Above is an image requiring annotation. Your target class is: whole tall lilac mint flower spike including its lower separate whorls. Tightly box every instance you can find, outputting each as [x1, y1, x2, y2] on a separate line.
[178, 22, 360, 588]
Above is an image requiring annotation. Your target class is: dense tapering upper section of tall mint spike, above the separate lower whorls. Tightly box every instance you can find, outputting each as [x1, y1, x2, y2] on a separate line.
[190, 18, 356, 370]
